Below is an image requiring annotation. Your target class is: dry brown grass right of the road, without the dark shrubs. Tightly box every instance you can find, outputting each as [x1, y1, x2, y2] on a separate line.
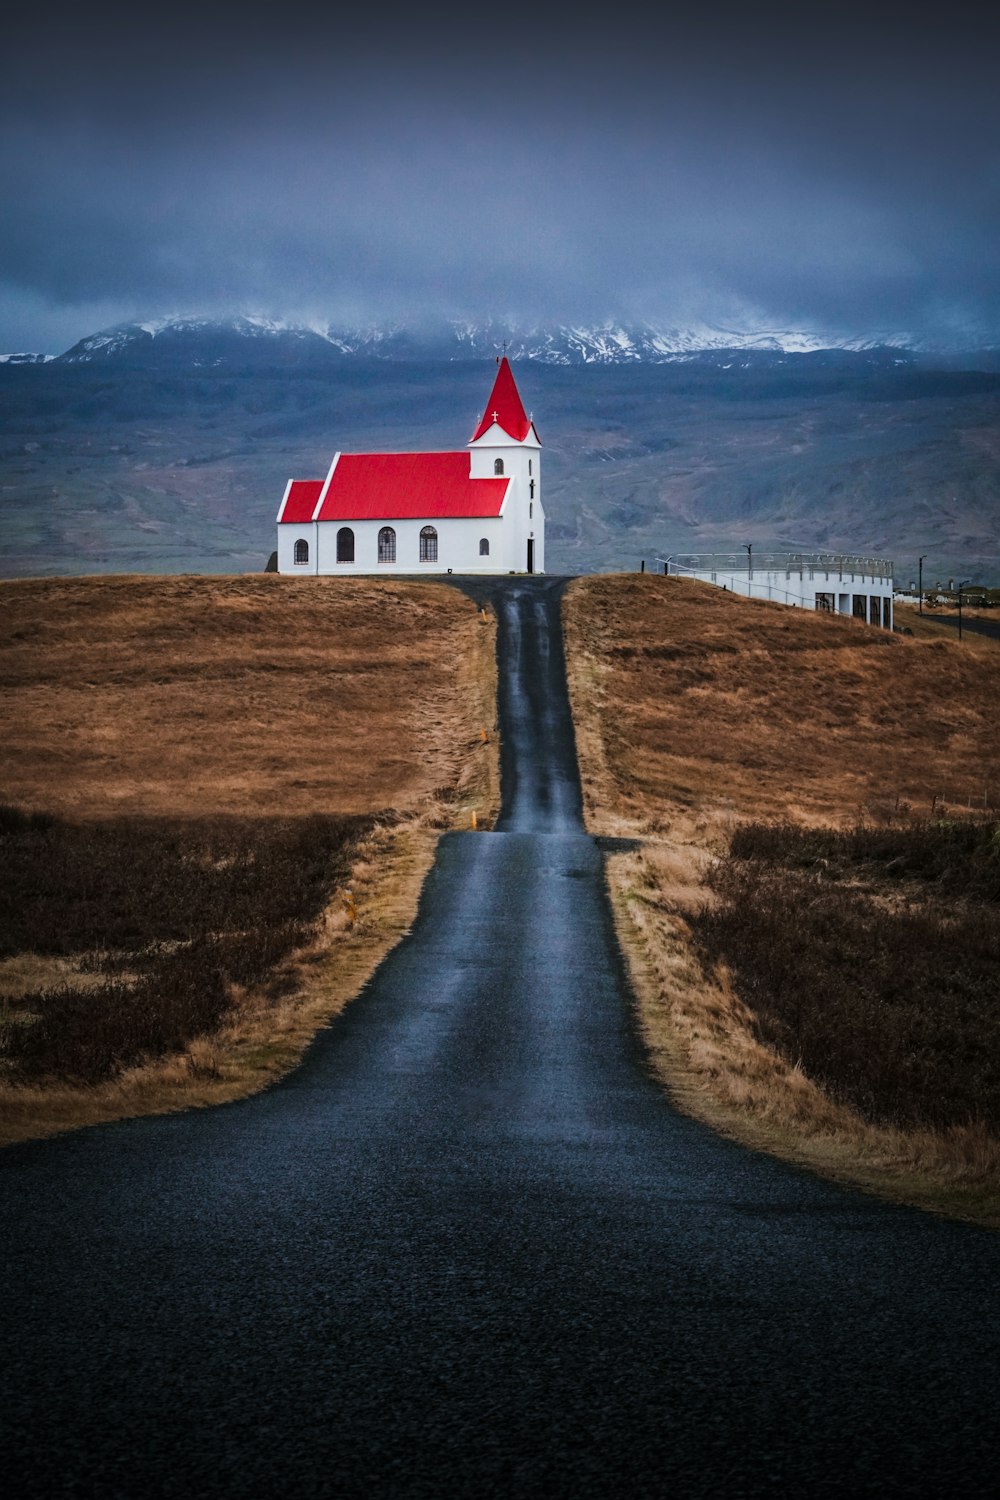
[565, 575, 1000, 1226]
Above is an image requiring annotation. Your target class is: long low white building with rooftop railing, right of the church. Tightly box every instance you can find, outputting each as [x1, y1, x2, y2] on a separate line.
[663, 549, 892, 630]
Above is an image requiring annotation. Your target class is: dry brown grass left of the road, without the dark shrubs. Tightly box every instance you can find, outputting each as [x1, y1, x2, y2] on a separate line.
[0, 575, 499, 1142]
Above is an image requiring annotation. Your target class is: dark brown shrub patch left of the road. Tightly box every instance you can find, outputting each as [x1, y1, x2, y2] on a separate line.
[0, 807, 372, 1082]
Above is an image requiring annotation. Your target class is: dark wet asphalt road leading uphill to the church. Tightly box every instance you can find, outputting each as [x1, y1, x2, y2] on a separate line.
[0, 579, 1000, 1497]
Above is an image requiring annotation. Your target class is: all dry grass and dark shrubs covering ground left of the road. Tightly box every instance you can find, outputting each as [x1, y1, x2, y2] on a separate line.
[0, 576, 498, 1140]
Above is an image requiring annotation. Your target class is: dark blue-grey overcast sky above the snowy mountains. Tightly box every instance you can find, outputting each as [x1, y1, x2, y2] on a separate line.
[0, 0, 1000, 353]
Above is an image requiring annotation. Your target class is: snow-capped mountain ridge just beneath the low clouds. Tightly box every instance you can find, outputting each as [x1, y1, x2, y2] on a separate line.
[48, 317, 1000, 369]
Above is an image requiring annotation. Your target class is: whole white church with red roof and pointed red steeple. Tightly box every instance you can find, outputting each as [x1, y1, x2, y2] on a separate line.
[277, 356, 546, 573]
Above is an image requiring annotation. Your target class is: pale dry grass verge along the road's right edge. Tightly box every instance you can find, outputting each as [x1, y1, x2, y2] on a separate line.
[562, 573, 1000, 1230]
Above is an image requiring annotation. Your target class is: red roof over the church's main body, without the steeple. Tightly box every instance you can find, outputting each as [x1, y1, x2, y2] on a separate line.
[279, 452, 510, 522]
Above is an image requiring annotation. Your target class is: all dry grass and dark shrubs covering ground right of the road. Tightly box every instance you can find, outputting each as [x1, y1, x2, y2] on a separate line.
[565, 576, 1000, 1223]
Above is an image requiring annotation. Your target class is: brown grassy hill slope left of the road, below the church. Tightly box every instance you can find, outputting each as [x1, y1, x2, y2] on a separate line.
[0, 575, 495, 818]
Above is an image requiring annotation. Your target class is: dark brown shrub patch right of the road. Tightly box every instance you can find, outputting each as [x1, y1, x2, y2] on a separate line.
[696, 821, 1000, 1130]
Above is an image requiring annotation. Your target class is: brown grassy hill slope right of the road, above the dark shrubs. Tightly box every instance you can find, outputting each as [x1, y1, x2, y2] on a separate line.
[565, 575, 1000, 833]
